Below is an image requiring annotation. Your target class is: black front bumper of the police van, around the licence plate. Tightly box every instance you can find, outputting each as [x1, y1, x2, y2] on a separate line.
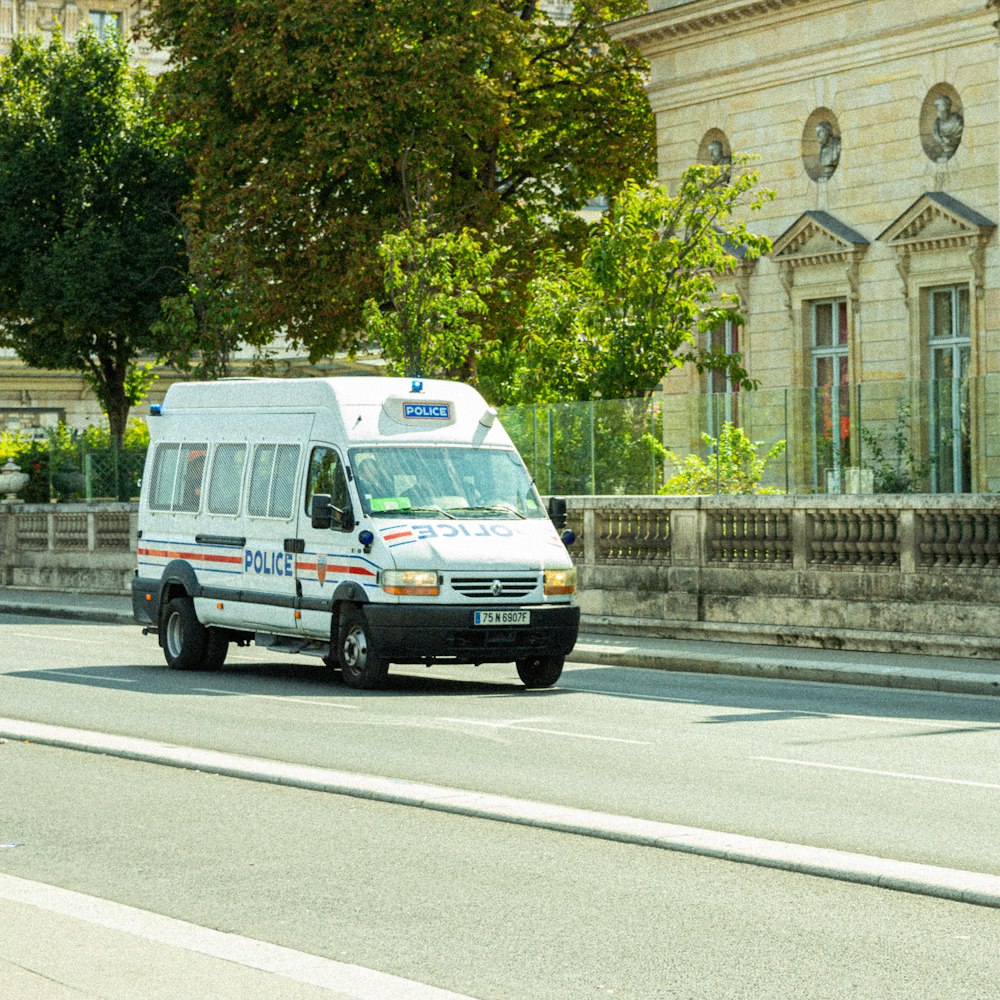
[362, 604, 580, 663]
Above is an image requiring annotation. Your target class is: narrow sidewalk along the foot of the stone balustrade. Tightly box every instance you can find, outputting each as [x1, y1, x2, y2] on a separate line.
[0, 588, 1000, 695]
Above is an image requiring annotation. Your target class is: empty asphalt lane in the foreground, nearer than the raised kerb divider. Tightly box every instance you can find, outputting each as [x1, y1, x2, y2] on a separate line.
[0, 741, 1000, 1000]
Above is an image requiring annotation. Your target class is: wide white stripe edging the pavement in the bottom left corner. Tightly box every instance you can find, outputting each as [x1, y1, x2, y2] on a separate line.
[0, 874, 471, 1000]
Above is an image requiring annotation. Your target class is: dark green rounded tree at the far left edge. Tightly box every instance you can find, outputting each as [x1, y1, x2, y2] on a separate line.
[0, 33, 187, 440]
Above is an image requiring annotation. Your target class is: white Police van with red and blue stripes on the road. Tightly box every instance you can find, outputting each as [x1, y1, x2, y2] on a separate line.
[132, 377, 580, 688]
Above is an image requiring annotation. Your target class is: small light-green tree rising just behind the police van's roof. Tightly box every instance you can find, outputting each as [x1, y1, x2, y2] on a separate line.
[364, 212, 501, 381]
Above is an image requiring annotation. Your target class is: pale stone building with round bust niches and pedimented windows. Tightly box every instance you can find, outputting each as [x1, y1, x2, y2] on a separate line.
[608, 0, 1000, 492]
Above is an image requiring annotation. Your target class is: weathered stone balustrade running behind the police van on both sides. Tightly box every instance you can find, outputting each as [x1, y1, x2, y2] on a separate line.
[0, 495, 1000, 657]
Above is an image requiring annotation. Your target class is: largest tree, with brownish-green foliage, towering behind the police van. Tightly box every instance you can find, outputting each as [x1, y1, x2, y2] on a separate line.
[145, 0, 654, 359]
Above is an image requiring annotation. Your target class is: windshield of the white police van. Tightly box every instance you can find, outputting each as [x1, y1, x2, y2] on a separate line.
[350, 446, 547, 520]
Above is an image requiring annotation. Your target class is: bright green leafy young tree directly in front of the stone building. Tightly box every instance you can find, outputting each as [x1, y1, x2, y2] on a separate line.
[509, 156, 773, 402]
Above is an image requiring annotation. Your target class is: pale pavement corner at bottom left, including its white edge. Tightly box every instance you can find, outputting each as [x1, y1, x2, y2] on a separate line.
[0, 874, 468, 1000]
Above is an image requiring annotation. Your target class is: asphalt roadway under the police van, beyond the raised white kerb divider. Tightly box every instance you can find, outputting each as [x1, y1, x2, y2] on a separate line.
[0, 617, 1000, 874]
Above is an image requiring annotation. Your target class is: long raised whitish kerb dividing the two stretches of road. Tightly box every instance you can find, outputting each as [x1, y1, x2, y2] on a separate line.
[0, 718, 1000, 909]
